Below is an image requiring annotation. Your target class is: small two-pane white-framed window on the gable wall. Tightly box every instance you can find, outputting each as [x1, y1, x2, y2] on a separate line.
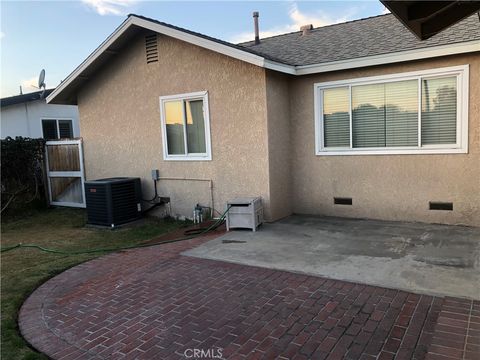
[160, 91, 212, 160]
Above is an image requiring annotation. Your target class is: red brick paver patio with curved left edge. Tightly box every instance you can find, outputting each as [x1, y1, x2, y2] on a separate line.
[19, 239, 480, 360]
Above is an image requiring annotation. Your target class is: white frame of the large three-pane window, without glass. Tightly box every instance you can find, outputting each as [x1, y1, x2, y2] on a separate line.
[314, 65, 469, 156]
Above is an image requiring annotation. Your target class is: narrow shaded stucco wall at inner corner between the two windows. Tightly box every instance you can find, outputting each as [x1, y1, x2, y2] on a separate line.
[266, 71, 293, 219]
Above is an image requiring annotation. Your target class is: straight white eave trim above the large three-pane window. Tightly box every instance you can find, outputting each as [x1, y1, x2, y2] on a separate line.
[295, 41, 480, 75]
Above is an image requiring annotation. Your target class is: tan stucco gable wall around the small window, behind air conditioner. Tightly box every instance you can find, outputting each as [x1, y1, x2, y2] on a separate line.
[78, 31, 272, 219]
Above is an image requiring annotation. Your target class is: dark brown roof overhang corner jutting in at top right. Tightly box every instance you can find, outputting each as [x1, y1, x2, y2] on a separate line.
[381, 0, 480, 40]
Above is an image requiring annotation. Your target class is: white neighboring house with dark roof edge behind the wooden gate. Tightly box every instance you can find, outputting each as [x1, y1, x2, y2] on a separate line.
[0, 89, 80, 140]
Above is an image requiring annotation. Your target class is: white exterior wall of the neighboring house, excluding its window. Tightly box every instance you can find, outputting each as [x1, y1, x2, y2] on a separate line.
[0, 100, 80, 139]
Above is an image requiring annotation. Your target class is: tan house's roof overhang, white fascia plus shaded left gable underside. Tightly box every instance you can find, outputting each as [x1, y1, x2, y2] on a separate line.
[47, 15, 480, 105]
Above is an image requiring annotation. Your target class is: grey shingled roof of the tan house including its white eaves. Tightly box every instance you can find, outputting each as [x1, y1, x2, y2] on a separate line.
[47, 14, 480, 104]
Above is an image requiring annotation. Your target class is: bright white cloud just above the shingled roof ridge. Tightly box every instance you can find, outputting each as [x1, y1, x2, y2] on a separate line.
[230, 3, 355, 44]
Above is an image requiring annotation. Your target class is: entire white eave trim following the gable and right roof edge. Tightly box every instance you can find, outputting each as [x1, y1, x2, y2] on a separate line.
[46, 15, 480, 103]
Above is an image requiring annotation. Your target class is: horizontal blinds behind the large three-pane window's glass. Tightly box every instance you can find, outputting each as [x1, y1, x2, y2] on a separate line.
[322, 76, 457, 148]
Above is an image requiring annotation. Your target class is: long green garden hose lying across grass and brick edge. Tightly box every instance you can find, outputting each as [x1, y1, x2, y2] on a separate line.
[0, 206, 230, 255]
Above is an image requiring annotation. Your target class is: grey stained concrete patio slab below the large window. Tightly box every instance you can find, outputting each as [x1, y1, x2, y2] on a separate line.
[184, 216, 480, 299]
